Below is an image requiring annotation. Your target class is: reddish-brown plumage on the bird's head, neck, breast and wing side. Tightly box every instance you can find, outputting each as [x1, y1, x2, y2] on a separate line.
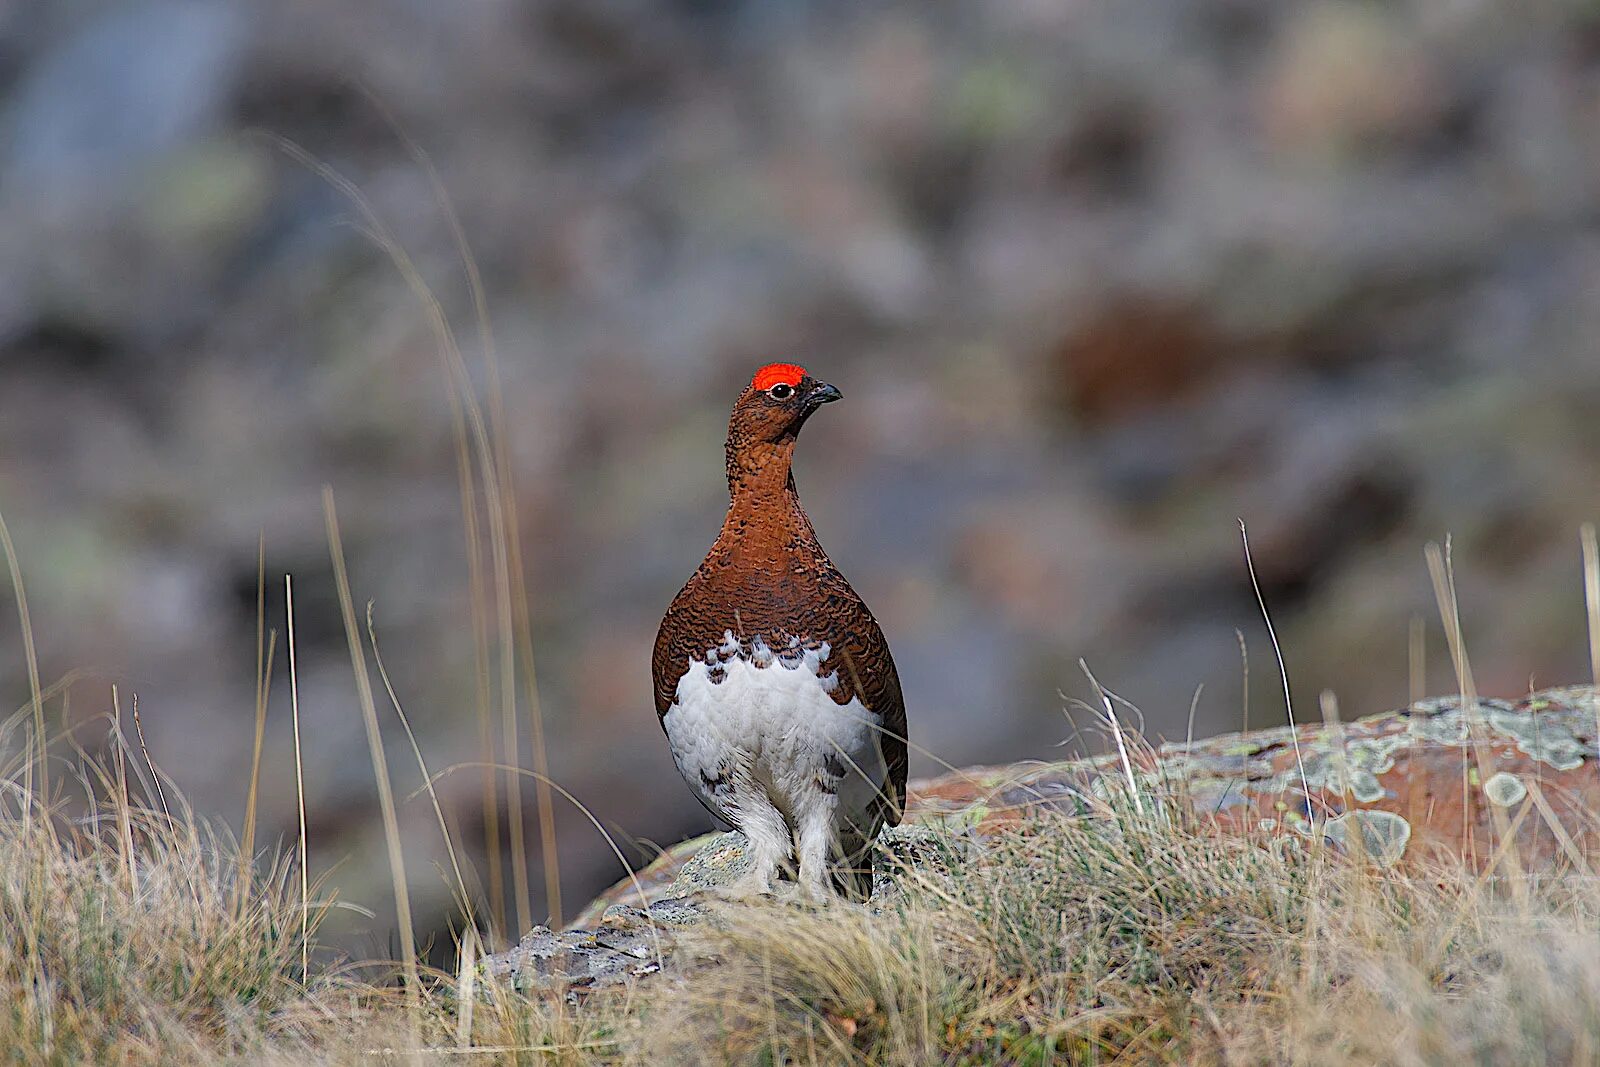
[653, 365, 906, 857]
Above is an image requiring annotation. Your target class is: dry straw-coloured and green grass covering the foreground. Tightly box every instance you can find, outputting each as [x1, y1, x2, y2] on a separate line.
[0, 668, 1600, 1064]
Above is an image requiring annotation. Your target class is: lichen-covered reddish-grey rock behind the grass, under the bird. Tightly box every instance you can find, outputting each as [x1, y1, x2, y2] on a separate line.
[576, 686, 1600, 926]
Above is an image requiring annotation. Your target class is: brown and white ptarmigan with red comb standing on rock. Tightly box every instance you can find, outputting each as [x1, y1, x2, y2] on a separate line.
[653, 363, 906, 897]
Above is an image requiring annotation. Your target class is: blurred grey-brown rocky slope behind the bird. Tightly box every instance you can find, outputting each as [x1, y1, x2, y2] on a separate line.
[0, 0, 1600, 952]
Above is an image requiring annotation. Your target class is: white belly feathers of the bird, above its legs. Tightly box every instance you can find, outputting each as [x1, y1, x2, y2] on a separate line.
[662, 633, 888, 837]
